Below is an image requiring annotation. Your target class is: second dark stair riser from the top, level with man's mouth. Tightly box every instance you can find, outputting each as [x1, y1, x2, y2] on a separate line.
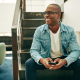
[22, 20, 45, 27]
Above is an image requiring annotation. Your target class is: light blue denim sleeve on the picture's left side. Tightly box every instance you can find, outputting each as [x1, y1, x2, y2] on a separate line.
[30, 27, 42, 64]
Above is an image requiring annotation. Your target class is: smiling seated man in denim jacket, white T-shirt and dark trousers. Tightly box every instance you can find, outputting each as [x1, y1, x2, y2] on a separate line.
[25, 4, 80, 80]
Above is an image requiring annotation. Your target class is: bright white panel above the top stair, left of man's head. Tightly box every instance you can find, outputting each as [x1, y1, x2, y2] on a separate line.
[26, 0, 55, 12]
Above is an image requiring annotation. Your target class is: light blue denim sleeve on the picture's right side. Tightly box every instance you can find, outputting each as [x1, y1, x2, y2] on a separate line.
[65, 29, 80, 67]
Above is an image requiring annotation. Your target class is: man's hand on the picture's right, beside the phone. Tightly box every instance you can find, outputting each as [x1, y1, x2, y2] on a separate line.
[49, 58, 67, 70]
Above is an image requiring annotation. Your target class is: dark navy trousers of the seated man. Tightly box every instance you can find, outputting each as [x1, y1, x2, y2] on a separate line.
[25, 58, 80, 80]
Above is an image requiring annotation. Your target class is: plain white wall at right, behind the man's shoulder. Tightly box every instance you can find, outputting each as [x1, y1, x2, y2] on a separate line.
[62, 0, 80, 45]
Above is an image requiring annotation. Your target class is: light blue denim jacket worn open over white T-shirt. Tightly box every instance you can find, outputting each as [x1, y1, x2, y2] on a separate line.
[30, 21, 80, 66]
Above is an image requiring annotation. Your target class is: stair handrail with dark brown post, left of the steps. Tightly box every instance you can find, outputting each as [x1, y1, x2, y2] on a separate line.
[11, 0, 25, 80]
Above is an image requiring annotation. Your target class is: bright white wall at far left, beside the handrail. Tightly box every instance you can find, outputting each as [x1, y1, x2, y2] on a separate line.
[0, 3, 15, 33]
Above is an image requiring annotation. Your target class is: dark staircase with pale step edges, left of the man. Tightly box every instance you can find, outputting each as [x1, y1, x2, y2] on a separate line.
[19, 12, 45, 80]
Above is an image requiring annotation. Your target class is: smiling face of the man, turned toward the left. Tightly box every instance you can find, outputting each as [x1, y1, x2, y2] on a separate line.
[44, 5, 60, 26]
